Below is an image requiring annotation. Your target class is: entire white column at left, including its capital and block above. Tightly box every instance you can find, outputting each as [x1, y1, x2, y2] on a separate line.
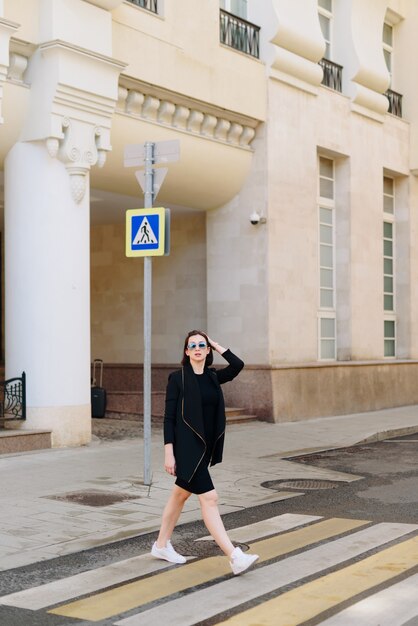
[5, 0, 126, 446]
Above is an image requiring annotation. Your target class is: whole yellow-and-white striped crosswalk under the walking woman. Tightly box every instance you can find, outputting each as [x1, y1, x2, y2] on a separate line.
[0, 514, 418, 626]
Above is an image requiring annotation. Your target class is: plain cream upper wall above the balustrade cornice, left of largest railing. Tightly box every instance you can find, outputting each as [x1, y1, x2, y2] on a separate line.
[112, 0, 265, 119]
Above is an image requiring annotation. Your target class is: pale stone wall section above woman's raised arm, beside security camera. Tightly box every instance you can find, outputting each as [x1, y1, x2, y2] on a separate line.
[207, 126, 269, 364]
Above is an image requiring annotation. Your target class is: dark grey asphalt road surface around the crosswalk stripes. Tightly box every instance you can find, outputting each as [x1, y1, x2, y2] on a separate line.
[0, 435, 418, 626]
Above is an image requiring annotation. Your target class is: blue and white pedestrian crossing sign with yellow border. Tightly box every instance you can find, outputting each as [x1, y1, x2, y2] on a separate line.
[126, 208, 166, 257]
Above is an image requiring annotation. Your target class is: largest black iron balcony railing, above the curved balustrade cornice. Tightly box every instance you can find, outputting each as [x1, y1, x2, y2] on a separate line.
[220, 9, 260, 59]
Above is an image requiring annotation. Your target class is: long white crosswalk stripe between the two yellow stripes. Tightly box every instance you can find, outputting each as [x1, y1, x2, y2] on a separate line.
[115, 523, 418, 626]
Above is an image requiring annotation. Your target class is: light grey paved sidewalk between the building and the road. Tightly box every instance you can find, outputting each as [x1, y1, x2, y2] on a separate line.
[0, 405, 418, 570]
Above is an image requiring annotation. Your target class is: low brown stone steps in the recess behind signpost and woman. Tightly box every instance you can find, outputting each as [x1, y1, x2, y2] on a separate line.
[106, 391, 257, 424]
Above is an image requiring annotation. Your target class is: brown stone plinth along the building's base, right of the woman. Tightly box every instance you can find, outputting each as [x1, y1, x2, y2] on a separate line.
[224, 361, 418, 423]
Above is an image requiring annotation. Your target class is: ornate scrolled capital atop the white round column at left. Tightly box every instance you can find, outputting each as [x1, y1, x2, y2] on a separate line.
[21, 40, 125, 202]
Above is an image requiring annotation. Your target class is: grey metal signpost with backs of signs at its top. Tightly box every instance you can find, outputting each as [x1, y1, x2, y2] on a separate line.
[124, 141, 180, 485]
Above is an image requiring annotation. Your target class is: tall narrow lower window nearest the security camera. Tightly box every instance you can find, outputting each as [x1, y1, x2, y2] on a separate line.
[318, 156, 336, 359]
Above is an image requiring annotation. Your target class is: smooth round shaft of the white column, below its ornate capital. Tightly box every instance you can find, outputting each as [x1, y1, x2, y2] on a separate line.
[5, 142, 91, 446]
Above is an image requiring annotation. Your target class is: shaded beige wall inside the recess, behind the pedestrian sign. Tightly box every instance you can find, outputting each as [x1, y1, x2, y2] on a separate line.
[91, 213, 206, 363]
